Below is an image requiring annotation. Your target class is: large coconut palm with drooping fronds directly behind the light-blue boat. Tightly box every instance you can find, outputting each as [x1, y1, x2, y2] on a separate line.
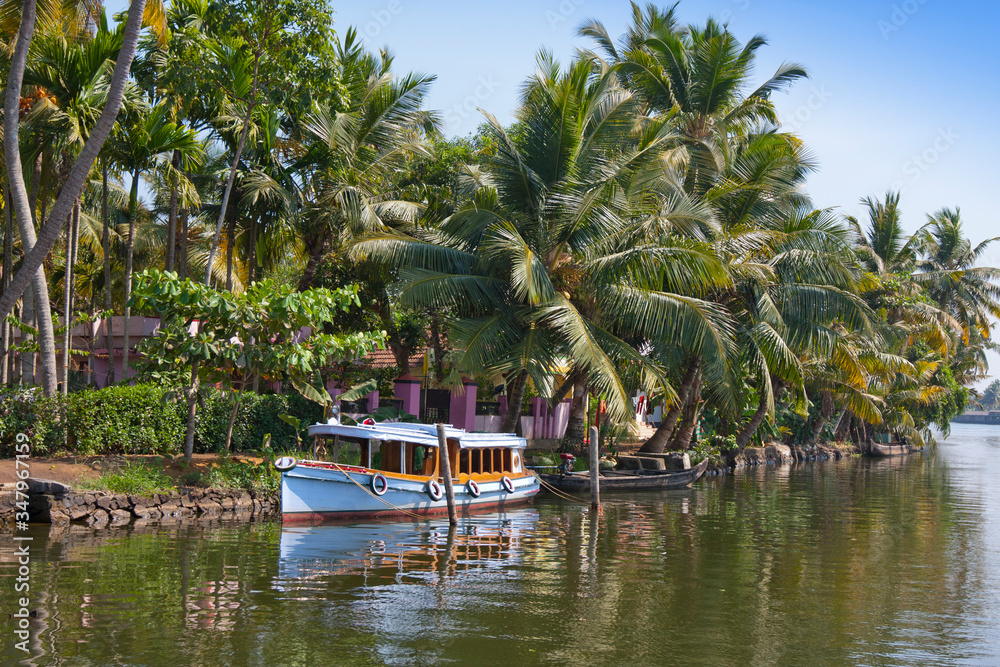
[357, 53, 730, 430]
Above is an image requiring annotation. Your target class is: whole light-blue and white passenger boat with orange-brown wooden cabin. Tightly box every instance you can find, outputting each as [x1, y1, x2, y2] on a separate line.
[274, 417, 539, 523]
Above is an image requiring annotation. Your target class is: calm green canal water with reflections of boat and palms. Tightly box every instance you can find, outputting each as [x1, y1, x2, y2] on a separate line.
[0, 425, 1000, 665]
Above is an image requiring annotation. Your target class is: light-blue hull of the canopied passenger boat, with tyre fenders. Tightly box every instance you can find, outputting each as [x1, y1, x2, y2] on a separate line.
[281, 464, 539, 523]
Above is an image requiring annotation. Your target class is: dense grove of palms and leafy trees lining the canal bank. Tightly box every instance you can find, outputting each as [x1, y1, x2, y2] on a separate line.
[0, 0, 1000, 451]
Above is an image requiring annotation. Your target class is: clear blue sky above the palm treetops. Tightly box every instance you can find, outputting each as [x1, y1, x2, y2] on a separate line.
[336, 0, 1000, 236]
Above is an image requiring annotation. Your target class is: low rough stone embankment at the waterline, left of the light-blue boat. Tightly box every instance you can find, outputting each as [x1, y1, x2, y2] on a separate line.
[0, 479, 281, 529]
